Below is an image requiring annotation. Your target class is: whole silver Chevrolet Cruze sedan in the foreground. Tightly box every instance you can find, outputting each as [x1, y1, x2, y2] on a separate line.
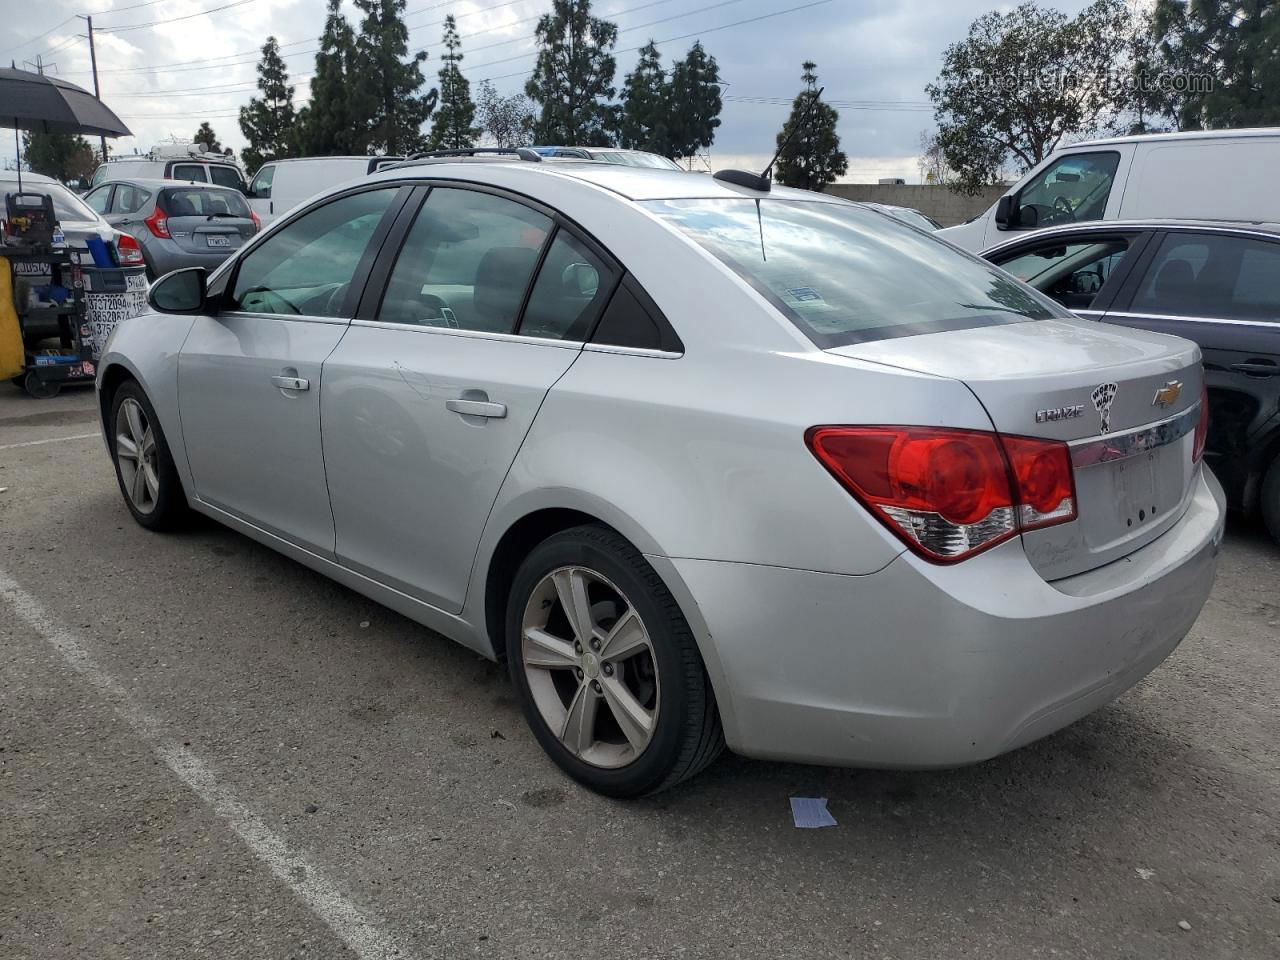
[99, 161, 1224, 796]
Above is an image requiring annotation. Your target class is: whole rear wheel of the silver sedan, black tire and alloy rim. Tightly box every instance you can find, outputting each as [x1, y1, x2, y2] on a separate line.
[507, 525, 724, 797]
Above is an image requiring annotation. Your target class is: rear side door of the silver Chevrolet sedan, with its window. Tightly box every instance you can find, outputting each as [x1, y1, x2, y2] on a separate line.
[321, 187, 617, 612]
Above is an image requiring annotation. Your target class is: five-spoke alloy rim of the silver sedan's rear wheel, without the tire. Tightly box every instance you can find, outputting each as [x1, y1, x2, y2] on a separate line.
[521, 566, 660, 768]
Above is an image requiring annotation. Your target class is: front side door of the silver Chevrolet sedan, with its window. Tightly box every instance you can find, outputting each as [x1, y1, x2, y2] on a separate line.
[178, 186, 408, 557]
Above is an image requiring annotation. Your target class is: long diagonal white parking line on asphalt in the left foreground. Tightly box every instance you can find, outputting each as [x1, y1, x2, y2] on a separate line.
[0, 570, 411, 960]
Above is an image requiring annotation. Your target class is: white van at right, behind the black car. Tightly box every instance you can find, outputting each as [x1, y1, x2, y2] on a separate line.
[936, 127, 1280, 253]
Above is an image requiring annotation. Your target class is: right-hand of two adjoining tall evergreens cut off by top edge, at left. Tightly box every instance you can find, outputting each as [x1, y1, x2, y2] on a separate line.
[352, 0, 439, 154]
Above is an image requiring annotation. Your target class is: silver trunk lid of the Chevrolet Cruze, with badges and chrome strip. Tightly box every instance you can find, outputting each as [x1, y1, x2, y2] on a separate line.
[831, 319, 1203, 580]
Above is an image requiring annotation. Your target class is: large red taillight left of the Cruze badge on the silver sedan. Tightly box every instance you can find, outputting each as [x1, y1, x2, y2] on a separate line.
[805, 426, 1075, 563]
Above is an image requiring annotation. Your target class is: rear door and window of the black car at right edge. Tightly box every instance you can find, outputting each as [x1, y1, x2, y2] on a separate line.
[1106, 232, 1280, 504]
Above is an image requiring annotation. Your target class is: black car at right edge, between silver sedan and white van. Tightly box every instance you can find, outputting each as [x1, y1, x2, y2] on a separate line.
[983, 220, 1280, 541]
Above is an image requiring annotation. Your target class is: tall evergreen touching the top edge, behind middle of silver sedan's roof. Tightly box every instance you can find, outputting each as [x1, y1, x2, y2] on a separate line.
[525, 0, 618, 146]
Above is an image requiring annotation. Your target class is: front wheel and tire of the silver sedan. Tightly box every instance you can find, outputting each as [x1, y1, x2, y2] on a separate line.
[106, 380, 189, 530]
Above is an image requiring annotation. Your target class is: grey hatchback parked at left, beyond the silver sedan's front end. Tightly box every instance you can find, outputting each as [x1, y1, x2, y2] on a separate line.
[84, 179, 261, 279]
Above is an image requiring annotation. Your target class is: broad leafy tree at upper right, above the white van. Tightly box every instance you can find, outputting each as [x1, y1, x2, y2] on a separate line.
[925, 0, 1130, 193]
